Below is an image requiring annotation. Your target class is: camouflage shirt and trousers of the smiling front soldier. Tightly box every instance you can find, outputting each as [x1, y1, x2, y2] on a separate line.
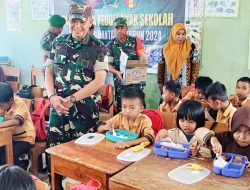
[46, 34, 108, 147]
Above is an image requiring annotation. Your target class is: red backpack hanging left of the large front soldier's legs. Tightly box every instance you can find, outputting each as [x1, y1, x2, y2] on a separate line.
[31, 98, 50, 142]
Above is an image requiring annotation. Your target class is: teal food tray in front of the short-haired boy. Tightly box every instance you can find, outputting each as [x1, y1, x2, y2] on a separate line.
[106, 129, 139, 142]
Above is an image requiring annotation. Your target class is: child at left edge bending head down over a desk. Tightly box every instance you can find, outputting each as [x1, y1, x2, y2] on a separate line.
[0, 82, 36, 169]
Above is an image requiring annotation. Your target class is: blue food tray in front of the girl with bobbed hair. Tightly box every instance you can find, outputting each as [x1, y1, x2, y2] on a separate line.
[154, 141, 190, 159]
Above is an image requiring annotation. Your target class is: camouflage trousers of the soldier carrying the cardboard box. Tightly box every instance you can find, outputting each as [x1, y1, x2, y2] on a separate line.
[114, 75, 145, 113]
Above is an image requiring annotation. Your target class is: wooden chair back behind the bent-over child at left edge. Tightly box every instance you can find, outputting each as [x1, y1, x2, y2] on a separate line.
[2, 65, 21, 93]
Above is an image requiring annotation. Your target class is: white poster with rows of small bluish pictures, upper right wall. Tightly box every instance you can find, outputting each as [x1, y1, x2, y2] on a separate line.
[205, 0, 239, 17]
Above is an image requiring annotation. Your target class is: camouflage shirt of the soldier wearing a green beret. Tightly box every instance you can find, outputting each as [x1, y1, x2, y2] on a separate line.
[40, 29, 57, 56]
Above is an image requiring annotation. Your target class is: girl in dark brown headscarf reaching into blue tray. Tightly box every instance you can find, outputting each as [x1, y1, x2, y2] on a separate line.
[195, 107, 250, 160]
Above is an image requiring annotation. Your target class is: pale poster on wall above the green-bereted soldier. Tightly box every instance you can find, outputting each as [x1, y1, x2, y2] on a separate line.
[31, 0, 49, 20]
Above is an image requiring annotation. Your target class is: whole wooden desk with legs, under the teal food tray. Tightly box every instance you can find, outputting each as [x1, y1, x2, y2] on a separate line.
[46, 139, 132, 190]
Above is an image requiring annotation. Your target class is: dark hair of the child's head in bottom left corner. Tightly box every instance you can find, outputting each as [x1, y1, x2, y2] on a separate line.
[0, 165, 36, 190]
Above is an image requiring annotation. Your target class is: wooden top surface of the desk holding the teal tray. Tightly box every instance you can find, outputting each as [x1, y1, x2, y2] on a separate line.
[46, 139, 132, 175]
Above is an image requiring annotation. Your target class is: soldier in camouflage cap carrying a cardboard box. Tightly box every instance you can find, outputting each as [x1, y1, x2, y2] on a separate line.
[107, 17, 146, 112]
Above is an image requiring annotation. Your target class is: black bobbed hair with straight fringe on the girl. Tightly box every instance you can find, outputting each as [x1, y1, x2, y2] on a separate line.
[176, 100, 205, 128]
